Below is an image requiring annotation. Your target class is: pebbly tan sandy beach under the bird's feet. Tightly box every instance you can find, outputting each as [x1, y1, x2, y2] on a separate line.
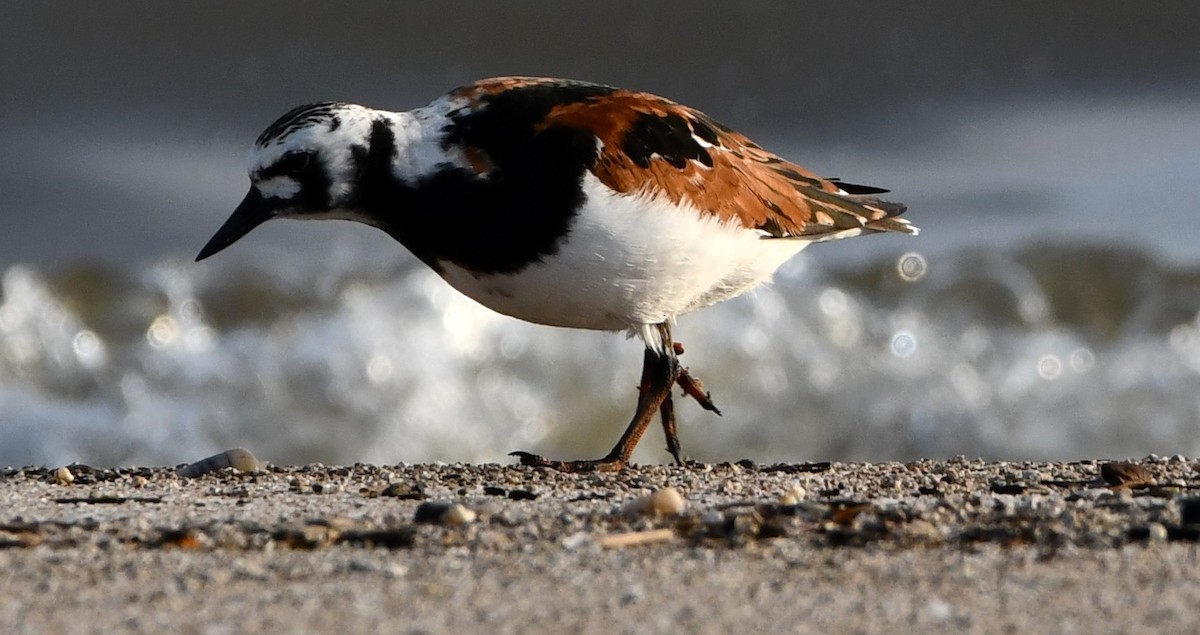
[0, 456, 1200, 634]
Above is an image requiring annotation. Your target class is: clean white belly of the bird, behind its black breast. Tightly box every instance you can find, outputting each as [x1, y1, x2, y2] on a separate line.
[439, 174, 808, 330]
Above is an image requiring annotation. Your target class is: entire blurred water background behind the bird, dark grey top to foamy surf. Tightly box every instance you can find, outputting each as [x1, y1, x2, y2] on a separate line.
[0, 0, 1200, 465]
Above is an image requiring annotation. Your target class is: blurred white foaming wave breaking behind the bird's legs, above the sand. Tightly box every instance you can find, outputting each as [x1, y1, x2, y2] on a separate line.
[0, 244, 1200, 466]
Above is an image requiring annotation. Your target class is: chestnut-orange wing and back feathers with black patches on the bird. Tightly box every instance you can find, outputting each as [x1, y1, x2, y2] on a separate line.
[453, 77, 917, 240]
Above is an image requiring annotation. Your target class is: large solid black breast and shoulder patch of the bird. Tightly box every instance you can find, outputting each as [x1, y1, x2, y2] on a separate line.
[354, 82, 614, 274]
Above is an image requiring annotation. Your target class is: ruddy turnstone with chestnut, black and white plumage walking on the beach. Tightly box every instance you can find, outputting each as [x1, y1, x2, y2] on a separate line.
[196, 77, 917, 471]
